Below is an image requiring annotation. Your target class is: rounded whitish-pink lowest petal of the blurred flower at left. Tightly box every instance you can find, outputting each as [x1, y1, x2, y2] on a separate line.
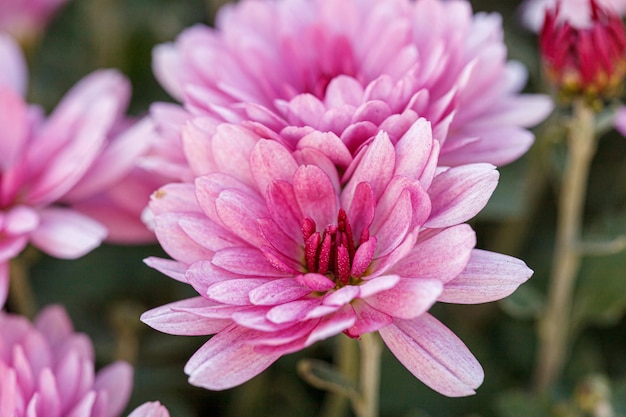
[31, 207, 107, 259]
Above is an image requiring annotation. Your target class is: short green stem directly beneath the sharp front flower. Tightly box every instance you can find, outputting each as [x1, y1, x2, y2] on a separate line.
[352, 333, 382, 417]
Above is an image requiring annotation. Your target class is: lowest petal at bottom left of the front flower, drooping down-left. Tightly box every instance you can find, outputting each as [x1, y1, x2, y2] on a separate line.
[185, 326, 281, 390]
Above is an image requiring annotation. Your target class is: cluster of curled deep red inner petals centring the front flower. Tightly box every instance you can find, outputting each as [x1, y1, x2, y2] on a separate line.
[302, 209, 375, 287]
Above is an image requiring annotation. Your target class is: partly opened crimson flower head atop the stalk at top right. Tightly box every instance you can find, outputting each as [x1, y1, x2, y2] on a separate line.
[539, 0, 626, 100]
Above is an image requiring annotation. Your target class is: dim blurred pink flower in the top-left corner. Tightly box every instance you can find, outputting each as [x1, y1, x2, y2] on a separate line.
[0, 0, 68, 39]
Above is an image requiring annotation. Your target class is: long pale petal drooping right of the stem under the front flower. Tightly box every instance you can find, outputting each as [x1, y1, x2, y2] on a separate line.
[379, 314, 484, 397]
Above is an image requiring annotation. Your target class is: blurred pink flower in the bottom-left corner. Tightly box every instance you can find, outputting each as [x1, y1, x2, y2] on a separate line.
[0, 306, 132, 417]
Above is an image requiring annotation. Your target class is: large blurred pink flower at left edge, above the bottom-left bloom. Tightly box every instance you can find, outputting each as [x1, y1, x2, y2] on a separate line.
[0, 35, 158, 306]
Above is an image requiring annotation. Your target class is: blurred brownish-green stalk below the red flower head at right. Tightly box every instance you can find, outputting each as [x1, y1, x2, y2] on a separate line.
[535, 100, 596, 393]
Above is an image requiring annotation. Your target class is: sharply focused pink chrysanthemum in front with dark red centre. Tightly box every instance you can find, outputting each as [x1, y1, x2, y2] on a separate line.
[142, 119, 532, 396]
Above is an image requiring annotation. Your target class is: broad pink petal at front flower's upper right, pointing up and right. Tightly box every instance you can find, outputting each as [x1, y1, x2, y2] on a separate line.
[425, 164, 499, 228]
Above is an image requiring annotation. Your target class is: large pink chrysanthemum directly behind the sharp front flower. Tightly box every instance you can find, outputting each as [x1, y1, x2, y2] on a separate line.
[154, 0, 551, 177]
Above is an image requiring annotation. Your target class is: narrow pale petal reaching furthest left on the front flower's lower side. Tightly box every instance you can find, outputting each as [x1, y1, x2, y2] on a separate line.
[141, 297, 231, 336]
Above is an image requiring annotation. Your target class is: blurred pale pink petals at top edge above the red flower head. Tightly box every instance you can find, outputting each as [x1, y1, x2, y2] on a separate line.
[520, 0, 626, 33]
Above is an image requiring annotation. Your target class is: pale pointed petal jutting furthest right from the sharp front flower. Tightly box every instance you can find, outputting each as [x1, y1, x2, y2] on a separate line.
[439, 249, 533, 304]
